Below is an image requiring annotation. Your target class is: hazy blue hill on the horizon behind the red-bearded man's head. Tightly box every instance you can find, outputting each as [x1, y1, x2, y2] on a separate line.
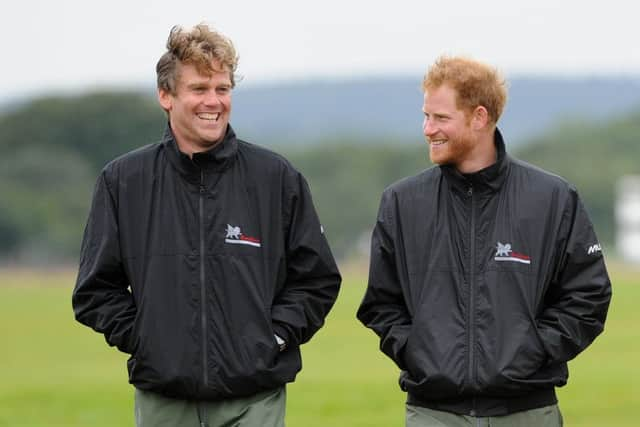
[232, 76, 640, 145]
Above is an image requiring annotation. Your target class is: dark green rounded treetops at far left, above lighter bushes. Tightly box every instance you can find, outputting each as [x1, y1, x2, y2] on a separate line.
[0, 92, 166, 172]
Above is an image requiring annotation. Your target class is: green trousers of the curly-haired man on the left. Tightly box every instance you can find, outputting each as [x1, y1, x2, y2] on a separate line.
[135, 386, 286, 427]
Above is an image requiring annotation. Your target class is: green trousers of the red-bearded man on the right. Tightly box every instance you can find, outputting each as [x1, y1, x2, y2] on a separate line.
[406, 405, 562, 427]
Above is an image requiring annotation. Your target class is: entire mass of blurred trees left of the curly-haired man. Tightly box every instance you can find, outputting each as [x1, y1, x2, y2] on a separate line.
[0, 92, 165, 264]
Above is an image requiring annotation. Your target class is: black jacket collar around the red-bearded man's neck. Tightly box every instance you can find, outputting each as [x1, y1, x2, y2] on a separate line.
[440, 128, 511, 193]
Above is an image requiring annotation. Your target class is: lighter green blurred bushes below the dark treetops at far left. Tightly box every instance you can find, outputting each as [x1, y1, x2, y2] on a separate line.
[0, 146, 95, 264]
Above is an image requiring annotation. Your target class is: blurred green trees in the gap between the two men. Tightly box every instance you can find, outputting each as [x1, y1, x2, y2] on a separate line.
[281, 140, 429, 258]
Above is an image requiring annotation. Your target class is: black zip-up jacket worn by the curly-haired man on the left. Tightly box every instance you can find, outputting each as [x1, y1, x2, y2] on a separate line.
[73, 127, 341, 400]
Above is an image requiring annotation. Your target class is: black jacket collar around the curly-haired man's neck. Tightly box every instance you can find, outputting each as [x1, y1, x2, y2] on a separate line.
[161, 123, 238, 179]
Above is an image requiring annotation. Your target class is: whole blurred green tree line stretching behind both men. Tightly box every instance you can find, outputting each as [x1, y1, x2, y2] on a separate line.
[0, 92, 640, 264]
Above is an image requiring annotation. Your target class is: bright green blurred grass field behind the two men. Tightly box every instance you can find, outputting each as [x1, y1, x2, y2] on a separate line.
[0, 266, 640, 427]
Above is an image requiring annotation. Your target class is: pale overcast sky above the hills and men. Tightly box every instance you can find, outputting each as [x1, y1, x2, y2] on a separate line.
[5, 0, 640, 101]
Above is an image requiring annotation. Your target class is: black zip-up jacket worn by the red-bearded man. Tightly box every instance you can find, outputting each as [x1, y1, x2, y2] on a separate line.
[358, 131, 611, 416]
